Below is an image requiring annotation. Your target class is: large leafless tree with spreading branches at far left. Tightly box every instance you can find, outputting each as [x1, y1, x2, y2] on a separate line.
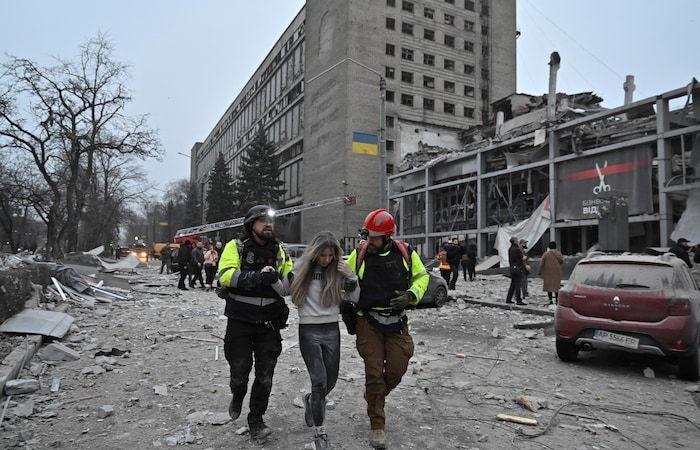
[0, 35, 160, 255]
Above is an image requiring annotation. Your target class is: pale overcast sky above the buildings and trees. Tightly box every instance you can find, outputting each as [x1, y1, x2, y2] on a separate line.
[0, 0, 700, 191]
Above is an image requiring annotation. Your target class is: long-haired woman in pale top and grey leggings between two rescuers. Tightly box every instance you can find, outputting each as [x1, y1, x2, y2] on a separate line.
[291, 231, 360, 450]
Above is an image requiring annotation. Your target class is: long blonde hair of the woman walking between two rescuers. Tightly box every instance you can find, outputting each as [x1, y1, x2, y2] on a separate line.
[291, 231, 345, 308]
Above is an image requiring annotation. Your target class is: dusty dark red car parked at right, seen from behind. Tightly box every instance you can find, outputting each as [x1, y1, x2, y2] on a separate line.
[554, 253, 700, 380]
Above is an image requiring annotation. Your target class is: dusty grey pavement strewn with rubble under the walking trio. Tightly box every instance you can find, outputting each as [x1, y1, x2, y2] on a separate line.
[0, 269, 700, 449]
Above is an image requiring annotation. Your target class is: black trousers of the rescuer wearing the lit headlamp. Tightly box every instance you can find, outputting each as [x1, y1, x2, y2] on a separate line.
[224, 319, 282, 425]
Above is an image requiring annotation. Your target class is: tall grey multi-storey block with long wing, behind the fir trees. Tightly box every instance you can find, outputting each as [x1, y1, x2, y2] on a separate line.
[191, 0, 516, 246]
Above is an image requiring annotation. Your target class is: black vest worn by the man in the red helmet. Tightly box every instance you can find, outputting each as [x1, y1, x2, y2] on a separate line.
[358, 245, 411, 309]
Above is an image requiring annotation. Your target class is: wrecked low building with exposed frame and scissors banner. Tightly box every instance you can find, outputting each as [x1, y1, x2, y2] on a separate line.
[389, 52, 700, 256]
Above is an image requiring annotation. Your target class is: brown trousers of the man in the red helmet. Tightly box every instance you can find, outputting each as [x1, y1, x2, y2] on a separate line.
[357, 317, 413, 430]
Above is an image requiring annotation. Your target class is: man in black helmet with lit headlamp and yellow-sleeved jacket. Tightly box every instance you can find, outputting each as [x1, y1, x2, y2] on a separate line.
[218, 205, 292, 440]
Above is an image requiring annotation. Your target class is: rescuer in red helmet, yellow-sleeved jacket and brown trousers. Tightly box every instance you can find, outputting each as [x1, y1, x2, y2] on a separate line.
[348, 209, 430, 449]
